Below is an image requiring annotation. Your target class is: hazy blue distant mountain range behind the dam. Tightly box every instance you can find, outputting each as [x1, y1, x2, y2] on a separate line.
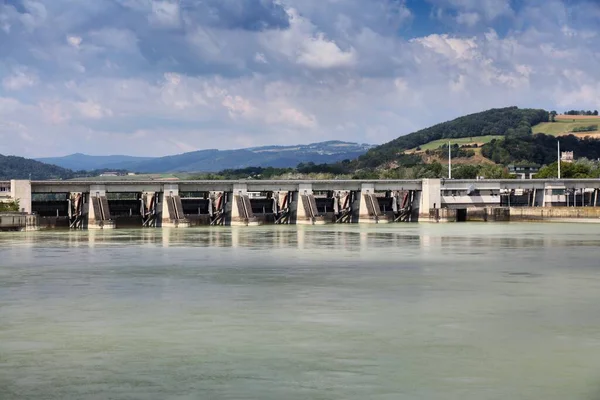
[36, 140, 374, 173]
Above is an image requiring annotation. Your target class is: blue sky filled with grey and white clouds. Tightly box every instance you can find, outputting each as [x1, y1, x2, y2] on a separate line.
[0, 0, 600, 157]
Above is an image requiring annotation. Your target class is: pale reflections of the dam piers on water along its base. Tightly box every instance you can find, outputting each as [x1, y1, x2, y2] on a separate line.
[0, 224, 600, 252]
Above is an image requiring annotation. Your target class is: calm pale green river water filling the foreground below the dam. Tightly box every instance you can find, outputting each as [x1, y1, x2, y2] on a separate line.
[0, 223, 600, 400]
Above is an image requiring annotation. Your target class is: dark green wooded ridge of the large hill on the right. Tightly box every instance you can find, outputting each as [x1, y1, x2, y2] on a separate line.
[358, 107, 550, 168]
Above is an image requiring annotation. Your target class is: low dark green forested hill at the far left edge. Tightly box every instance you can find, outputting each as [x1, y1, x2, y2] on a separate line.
[0, 154, 75, 180]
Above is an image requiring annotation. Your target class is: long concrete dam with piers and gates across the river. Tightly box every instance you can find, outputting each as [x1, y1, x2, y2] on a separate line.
[0, 179, 600, 229]
